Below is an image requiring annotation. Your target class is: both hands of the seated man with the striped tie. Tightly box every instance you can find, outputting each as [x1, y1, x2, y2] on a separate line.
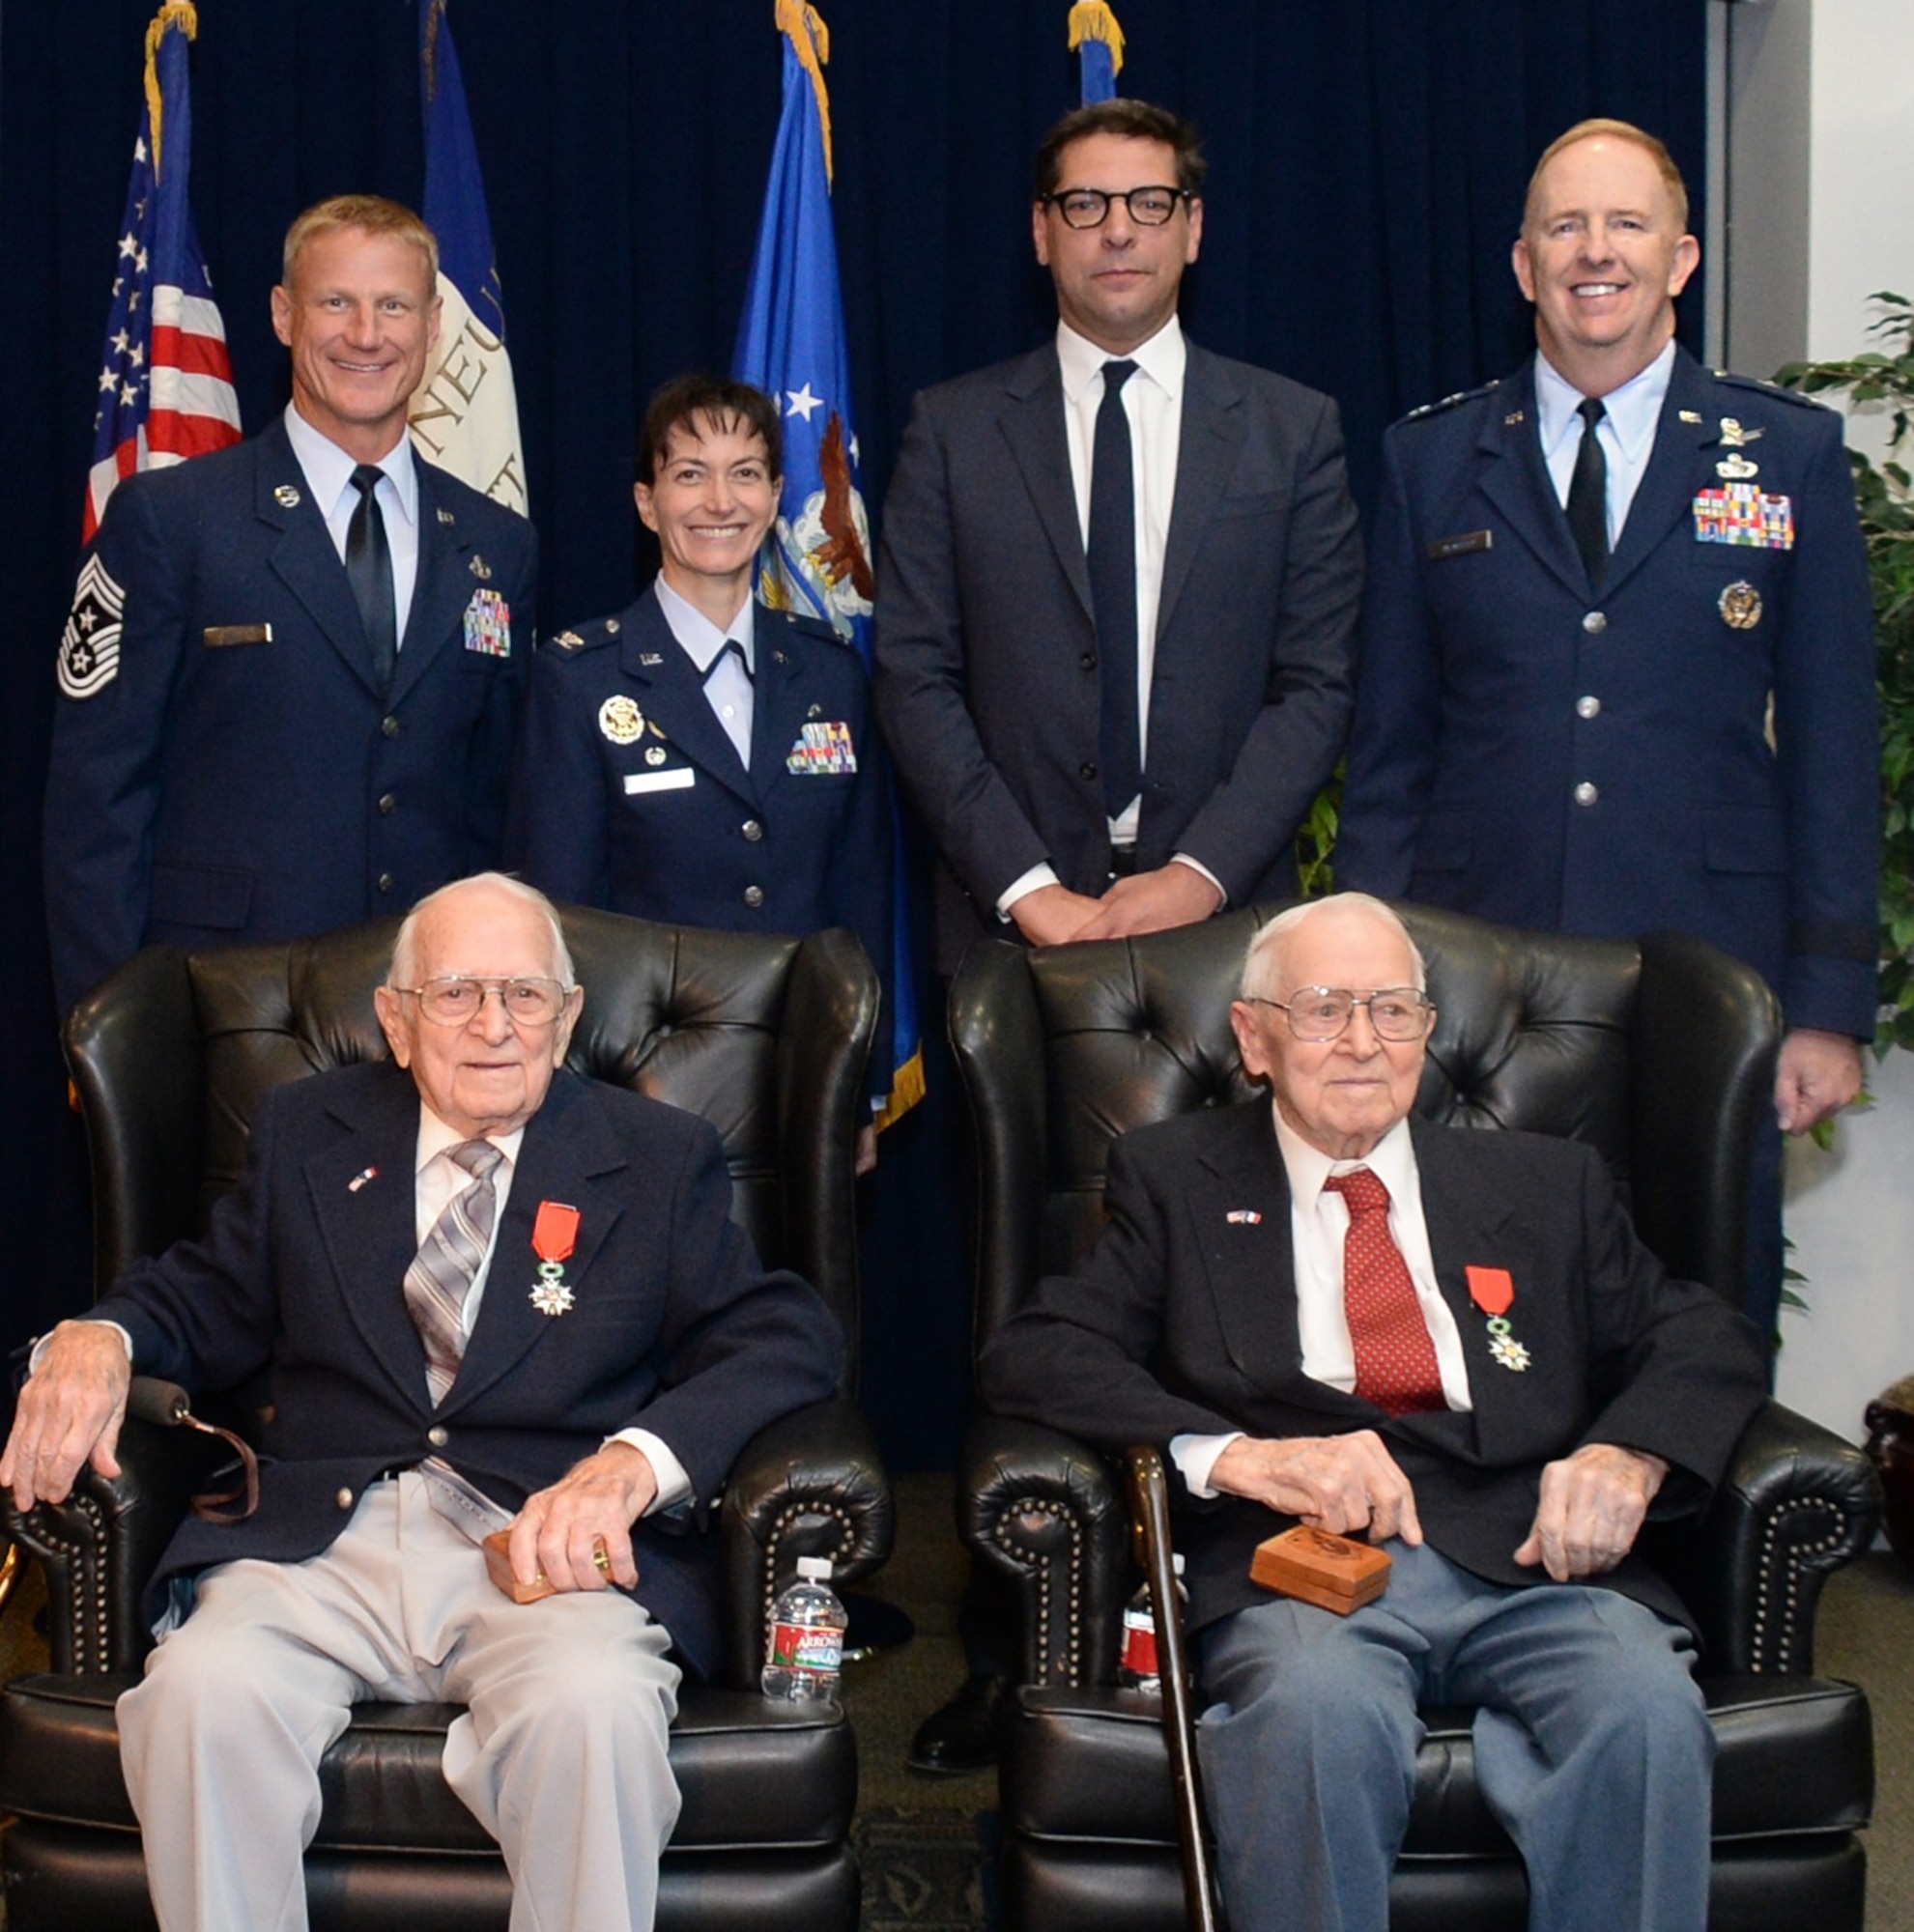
[0, 1321, 657, 1592]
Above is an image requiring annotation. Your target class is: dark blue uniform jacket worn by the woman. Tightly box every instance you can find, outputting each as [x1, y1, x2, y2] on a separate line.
[506, 589, 893, 1086]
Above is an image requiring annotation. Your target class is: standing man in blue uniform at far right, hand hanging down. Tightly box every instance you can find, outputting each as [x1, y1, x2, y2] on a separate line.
[1336, 122, 1879, 1329]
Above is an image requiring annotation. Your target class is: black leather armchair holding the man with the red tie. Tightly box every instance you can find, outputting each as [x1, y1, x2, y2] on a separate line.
[951, 906, 1879, 1932]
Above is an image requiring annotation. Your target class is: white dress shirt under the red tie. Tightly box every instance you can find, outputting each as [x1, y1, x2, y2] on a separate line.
[1170, 1103, 1473, 1495]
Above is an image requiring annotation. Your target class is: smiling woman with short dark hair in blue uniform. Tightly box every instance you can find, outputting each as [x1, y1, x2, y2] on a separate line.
[506, 375, 891, 1157]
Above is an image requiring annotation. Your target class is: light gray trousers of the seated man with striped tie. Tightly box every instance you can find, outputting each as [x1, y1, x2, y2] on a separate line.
[118, 1472, 678, 1932]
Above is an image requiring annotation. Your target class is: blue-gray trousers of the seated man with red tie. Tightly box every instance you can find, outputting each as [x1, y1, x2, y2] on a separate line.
[1197, 1540, 1715, 1932]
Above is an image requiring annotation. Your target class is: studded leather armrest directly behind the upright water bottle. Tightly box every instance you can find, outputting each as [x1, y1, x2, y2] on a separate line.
[719, 1397, 897, 1690]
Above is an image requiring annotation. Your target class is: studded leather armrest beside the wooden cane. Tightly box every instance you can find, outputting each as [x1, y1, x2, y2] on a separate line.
[957, 1416, 1129, 1687]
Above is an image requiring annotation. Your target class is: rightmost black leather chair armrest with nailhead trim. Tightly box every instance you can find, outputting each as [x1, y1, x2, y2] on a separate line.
[1657, 1403, 1881, 1675]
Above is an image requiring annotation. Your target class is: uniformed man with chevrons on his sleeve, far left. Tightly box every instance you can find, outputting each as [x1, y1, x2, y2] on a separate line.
[44, 195, 537, 1012]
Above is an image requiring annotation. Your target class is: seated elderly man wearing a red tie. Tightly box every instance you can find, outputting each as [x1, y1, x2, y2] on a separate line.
[983, 893, 1763, 1932]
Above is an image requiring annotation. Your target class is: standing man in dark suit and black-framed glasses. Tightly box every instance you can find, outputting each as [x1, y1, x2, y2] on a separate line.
[875, 100, 1361, 972]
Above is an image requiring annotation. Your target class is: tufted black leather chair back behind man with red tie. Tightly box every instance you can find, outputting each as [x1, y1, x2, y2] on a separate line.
[951, 904, 1781, 1345]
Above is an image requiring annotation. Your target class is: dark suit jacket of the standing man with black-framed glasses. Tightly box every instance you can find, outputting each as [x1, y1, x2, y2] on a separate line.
[875, 344, 1363, 972]
